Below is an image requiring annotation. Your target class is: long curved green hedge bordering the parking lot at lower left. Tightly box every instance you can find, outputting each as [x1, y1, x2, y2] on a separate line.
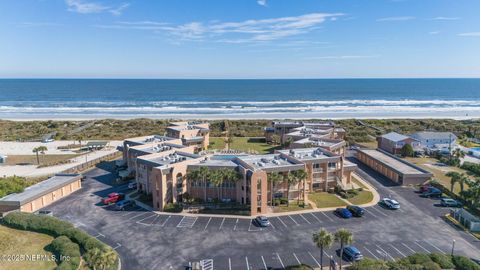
[2, 212, 119, 269]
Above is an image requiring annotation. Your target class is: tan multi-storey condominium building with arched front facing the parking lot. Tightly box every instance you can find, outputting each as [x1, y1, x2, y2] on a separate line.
[129, 143, 356, 215]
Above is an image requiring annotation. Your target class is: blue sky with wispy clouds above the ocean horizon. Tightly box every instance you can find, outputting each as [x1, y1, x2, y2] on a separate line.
[0, 0, 480, 78]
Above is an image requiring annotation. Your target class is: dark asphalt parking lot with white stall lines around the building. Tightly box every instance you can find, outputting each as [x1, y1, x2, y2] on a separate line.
[49, 161, 480, 269]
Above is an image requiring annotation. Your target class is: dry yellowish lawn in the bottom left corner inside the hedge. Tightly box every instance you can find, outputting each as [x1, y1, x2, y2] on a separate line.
[0, 225, 57, 270]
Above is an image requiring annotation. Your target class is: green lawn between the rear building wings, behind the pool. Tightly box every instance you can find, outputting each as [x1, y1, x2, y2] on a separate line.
[209, 137, 278, 154]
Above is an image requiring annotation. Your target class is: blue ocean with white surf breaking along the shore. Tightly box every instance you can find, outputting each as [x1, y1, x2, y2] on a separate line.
[0, 79, 480, 120]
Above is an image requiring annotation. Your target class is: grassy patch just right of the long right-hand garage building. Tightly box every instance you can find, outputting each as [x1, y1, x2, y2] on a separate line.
[405, 157, 467, 194]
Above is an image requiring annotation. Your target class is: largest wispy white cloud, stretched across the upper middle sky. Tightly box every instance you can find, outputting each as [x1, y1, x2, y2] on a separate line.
[97, 13, 343, 43]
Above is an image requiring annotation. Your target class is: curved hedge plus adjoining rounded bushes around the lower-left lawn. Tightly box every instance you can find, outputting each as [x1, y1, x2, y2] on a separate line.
[2, 212, 119, 270]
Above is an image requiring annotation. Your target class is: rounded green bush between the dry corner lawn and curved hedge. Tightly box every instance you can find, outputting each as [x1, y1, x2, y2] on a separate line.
[48, 235, 81, 270]
